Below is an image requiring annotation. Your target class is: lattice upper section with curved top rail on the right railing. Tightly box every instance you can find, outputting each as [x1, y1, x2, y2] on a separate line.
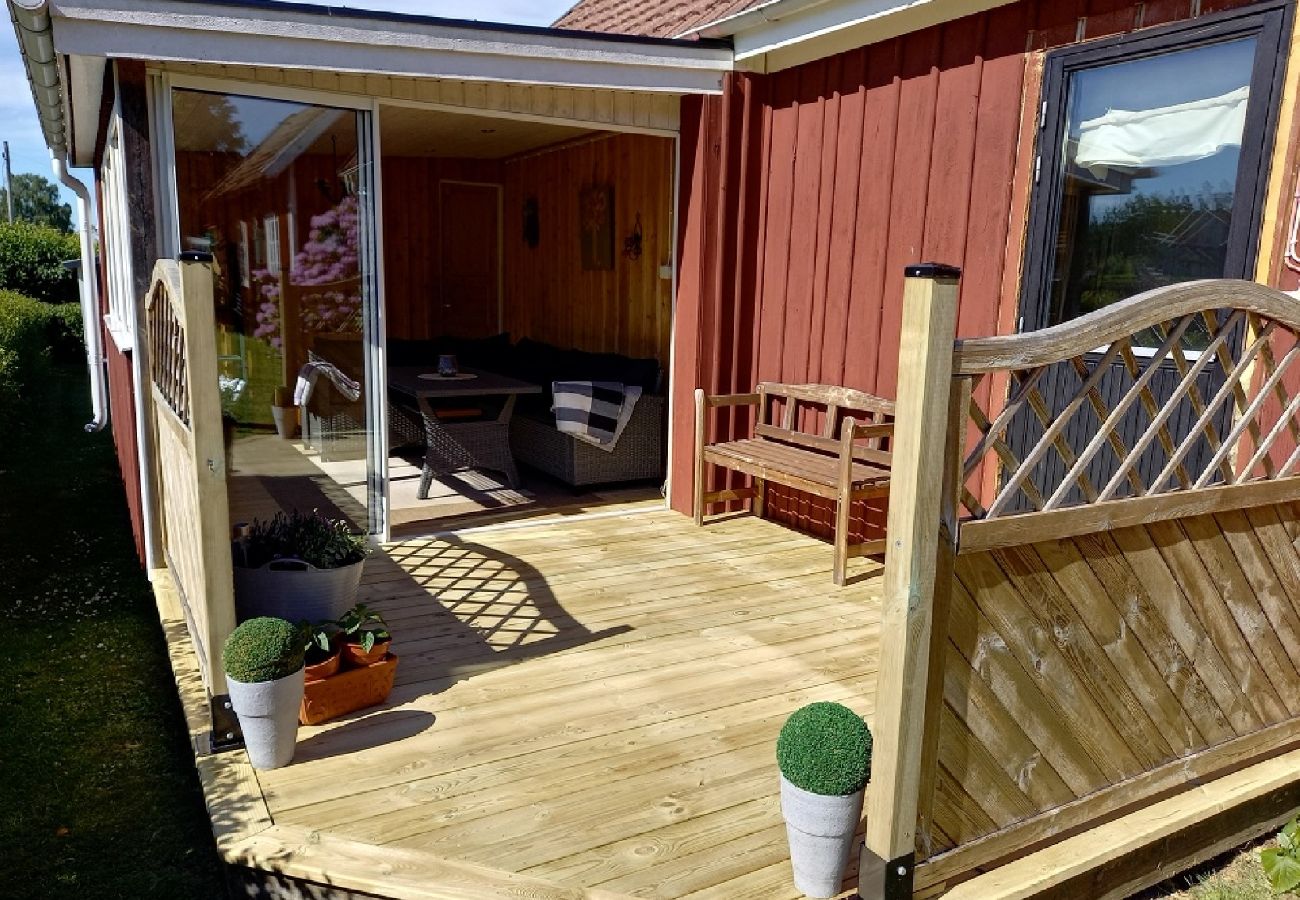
[954, 282, 1300, 519]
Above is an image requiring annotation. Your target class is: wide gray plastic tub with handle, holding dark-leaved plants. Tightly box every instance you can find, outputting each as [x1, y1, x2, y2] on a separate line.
[235, 559, 365, 622]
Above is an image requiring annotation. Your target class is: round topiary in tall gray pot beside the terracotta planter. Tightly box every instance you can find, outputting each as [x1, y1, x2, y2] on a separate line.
[221, 616, 303, 769]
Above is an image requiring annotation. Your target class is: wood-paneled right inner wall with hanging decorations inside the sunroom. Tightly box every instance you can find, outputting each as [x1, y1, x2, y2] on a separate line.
[503, 134, 673, 367]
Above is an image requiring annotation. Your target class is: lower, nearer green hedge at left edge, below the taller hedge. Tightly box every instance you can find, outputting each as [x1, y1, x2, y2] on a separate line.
[0, 290, 82, 407]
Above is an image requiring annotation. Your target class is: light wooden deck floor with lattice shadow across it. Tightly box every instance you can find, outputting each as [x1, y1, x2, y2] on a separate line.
[208, 511, 879, 897]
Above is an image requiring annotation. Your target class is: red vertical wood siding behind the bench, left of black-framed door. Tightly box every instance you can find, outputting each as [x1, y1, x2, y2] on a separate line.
[671, 0, 1268, 531]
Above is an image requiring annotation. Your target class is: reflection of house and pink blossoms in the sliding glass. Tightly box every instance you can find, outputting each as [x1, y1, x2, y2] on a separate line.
[173, 90, 363, 425]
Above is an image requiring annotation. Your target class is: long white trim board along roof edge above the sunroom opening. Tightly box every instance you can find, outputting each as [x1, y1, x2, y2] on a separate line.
[52, 0, 732, 94]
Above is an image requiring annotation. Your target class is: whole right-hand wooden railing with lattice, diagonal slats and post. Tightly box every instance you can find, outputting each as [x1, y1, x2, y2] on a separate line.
[862, 267, 1300, 897]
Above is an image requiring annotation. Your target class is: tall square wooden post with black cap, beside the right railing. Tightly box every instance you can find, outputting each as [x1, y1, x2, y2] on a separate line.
[858, 263, 961, 900]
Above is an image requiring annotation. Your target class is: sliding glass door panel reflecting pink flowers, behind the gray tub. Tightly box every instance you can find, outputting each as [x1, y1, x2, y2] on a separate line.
[168, 85, 387, 535]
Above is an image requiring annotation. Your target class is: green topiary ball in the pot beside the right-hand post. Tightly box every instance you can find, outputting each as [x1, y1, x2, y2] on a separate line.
[776, 702, 871, 797]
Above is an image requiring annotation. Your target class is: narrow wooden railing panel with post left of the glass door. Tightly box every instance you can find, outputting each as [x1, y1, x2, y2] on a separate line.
[146, 253, 235, 696]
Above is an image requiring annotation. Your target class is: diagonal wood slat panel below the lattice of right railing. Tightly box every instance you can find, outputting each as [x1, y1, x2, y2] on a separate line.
[917, 503, 1300, 887]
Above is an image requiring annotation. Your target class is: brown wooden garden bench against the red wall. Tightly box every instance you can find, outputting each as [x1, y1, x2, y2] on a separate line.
[694, 381, 894, 584]
